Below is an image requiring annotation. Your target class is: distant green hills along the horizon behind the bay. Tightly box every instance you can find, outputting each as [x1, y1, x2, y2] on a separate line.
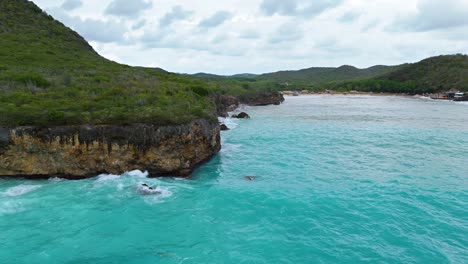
[195, 55, 468, 94]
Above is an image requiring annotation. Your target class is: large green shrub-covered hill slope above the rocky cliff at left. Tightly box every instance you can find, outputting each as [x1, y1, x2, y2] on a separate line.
[0, 0, 215, 126]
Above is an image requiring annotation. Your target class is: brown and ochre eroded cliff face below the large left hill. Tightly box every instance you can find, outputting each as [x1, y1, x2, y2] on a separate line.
[0, 120, 221, 179]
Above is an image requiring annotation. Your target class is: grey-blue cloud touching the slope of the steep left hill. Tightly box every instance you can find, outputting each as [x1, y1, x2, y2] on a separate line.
[47, 8, 127, 44]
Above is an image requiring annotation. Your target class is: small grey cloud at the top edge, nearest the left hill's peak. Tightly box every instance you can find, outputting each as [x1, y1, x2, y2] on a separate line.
[105, 0, 152, 18]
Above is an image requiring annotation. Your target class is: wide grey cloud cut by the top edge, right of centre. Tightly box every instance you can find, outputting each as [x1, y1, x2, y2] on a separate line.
[260, 0, 343, 17]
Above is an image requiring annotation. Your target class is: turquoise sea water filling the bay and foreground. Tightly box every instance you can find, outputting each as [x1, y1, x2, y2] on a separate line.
[0, 96, 468, 263]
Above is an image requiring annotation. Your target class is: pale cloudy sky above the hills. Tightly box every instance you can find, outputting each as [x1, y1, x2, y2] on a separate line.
[33, 0, 468, 74]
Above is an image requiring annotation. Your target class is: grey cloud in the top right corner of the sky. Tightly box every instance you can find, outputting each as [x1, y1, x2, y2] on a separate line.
[389, 0, 468, 32]
